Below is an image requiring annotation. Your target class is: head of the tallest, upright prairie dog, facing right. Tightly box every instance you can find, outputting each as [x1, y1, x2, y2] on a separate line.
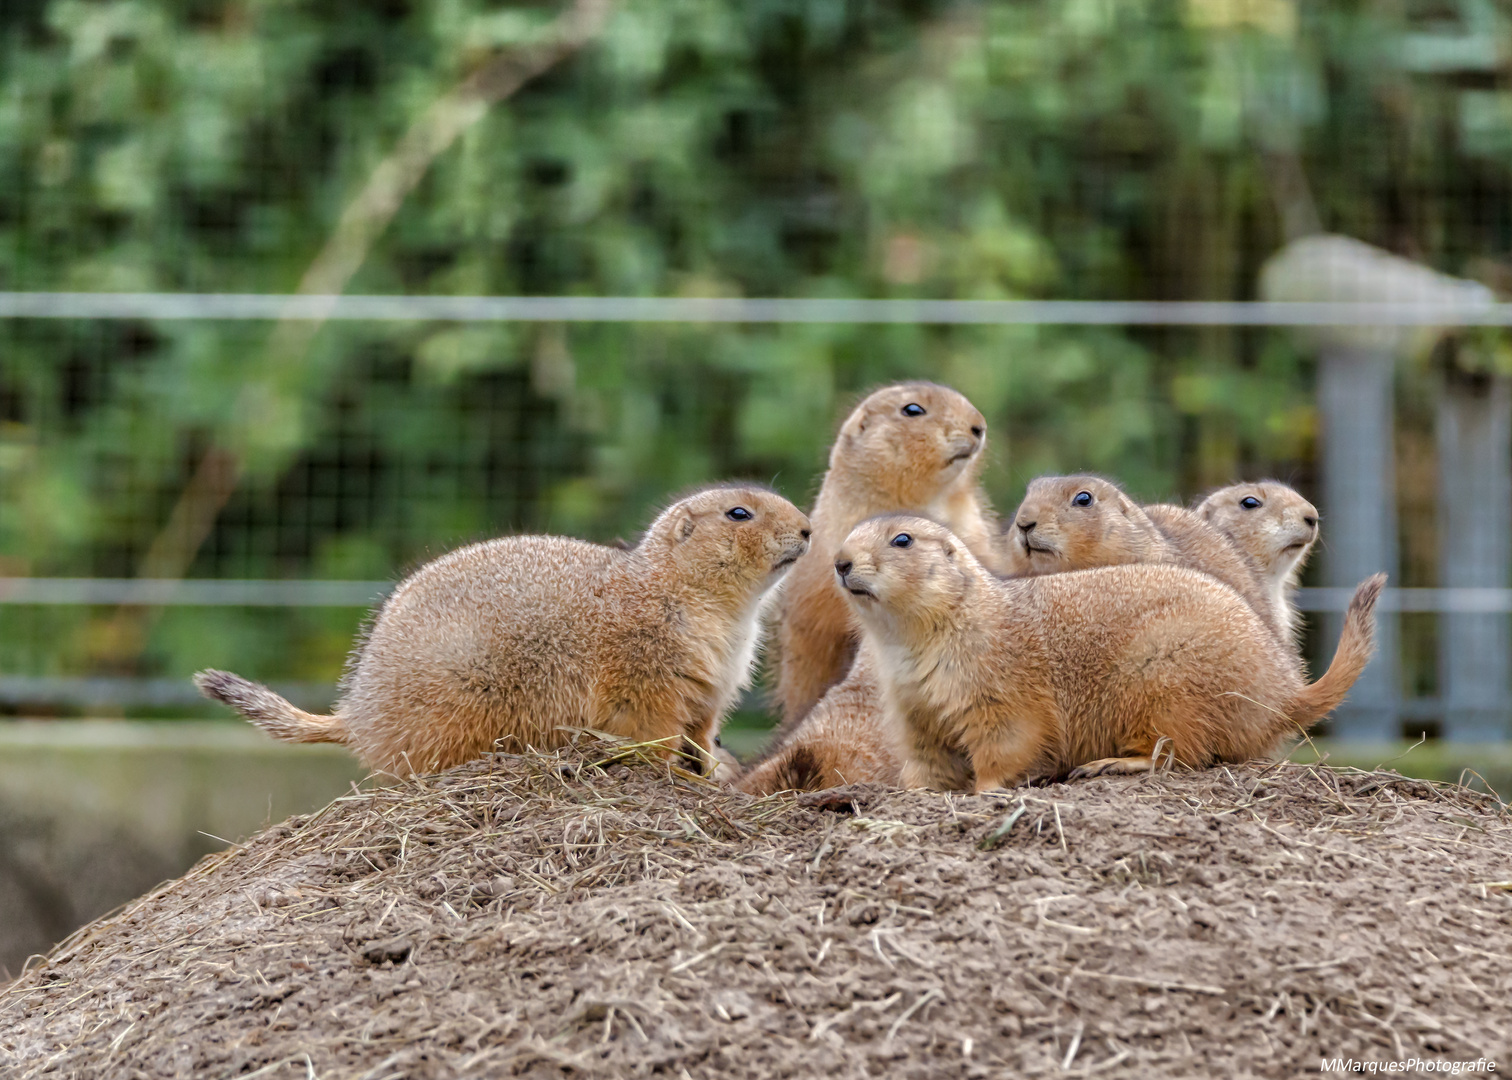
[829, 383, 987, 511]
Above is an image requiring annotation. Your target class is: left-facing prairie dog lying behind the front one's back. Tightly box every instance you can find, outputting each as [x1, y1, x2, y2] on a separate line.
[1012, 476, 1291, 641]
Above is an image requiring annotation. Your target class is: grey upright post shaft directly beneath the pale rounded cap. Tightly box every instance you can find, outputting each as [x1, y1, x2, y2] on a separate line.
[1318, 342, 1400, 743]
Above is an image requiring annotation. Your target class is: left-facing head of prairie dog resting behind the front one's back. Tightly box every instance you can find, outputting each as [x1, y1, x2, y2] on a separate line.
[1009, 476, 1161, 575]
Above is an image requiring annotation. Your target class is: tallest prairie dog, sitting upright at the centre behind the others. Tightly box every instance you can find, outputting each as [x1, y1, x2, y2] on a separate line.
[777, 383, 998, 738]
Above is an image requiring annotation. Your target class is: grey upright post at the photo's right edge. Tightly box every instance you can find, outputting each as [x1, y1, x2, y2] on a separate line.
[1438, 371, 1512, 743]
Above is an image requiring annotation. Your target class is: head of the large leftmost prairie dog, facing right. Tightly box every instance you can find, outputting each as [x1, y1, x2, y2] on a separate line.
[650, 484, 809, 604]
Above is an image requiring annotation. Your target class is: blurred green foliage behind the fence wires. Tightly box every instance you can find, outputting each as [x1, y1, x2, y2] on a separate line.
[0, 0, 1512, 692]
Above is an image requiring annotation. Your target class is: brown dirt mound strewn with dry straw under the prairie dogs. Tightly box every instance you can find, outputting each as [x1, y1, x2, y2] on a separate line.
[0, 747, 1512, 1080]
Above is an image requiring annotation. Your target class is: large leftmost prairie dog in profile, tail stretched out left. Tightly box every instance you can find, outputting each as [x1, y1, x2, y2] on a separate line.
[204, 484, 809, 774]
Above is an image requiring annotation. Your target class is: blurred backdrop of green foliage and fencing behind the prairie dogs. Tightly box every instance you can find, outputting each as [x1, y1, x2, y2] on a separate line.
[0, 0, 1512, 979]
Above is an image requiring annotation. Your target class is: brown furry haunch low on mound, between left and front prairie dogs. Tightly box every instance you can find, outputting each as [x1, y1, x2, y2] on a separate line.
[735, 653, 903, 796]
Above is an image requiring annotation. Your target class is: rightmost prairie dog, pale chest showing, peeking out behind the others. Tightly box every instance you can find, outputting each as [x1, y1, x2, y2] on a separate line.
[1196, 479, 1318, 643]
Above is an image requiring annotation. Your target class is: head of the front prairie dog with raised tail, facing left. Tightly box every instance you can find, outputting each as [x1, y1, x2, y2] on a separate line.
[835, 514, 987, 637]
